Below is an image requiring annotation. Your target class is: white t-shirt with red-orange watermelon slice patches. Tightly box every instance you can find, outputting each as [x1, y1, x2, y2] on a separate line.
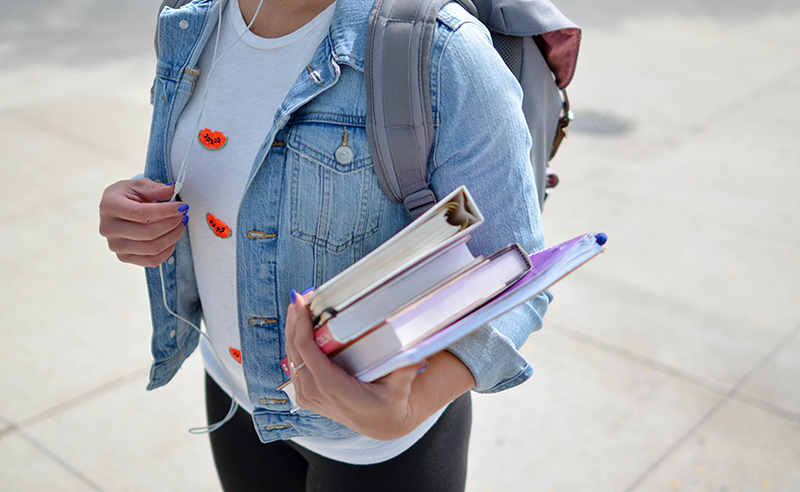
[170, 0, 443, 464]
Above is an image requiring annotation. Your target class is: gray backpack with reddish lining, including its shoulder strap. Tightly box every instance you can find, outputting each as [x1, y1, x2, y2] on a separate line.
[156, 0, 581, 218]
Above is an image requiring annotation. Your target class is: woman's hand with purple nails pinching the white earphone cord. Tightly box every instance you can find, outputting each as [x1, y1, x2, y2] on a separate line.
[100, 178, 189, 267]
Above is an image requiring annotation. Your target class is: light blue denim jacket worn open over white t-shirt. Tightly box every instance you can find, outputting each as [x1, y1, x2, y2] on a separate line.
[145, 0, 550, 442]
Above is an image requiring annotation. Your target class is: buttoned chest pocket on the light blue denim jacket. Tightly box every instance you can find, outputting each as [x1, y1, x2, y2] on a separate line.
[286, 114, 386, 253]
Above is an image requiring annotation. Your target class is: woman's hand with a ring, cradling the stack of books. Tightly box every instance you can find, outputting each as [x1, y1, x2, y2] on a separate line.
[286, 294, 434, 440]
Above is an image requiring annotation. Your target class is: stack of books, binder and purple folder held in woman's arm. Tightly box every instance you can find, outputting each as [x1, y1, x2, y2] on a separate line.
[279, 187, 606, 396]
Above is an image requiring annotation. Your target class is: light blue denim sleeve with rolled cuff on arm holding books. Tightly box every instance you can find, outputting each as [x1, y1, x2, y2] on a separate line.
[430, 4, 552, 393]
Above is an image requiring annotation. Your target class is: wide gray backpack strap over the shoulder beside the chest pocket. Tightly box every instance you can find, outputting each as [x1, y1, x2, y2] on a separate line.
[364, 0, 466, 218]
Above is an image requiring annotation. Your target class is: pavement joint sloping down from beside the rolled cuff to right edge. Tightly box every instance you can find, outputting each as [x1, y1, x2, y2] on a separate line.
[549, 324, 800, 423]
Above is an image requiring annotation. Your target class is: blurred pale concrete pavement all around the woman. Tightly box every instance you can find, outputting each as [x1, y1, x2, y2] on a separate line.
[0, 0, 800, 492]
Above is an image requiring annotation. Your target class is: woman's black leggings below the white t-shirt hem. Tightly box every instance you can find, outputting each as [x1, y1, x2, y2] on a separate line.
[206, 374, 472, 492]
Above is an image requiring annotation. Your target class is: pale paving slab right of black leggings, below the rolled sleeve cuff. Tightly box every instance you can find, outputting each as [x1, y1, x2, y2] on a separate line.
[467, 329, 720, 492]
